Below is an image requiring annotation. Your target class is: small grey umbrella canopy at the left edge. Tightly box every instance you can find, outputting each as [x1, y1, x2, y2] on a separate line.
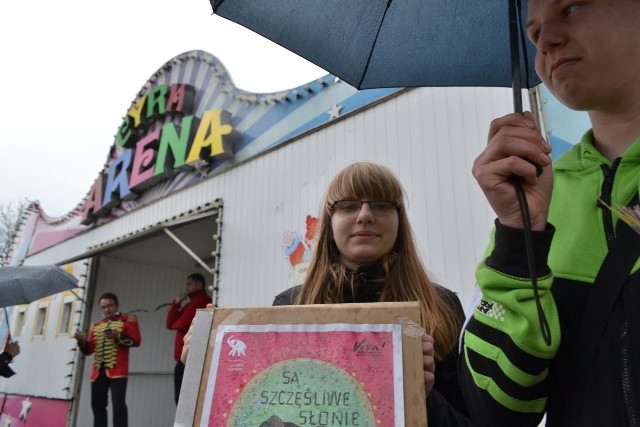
[0, 265, 78, 307]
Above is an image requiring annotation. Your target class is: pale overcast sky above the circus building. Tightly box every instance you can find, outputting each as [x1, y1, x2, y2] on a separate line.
[0, 0, 326, 217]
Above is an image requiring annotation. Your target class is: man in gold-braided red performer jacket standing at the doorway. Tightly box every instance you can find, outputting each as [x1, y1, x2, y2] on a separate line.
[75, 292, 141, 427]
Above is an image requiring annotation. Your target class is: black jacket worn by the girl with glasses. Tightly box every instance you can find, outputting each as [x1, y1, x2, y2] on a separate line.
[273, 268, 472, 427]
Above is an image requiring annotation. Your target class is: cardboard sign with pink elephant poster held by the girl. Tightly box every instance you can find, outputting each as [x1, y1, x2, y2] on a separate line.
[175, 303, 426, 427]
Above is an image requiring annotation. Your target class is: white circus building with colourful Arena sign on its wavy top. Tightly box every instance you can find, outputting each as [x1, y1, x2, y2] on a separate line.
[0, 51, 584, 426]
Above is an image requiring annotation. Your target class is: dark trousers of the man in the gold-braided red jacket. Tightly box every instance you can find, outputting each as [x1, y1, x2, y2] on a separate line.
[91, 369, 128, 427]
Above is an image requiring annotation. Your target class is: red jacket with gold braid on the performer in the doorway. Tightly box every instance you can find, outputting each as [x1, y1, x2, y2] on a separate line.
[80, 313, 141, 382]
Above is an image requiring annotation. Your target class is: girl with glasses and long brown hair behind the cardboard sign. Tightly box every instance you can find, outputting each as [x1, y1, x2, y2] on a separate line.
[273, 162, 470, 427]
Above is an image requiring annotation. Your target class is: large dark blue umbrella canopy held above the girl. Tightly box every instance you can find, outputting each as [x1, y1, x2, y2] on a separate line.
[210, 0, 540, 112]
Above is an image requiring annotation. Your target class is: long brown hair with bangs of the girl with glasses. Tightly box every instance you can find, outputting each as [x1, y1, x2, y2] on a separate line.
[297, 162, 460, 360]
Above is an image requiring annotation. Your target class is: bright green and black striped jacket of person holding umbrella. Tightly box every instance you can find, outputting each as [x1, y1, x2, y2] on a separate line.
[459, 132, 640, 427]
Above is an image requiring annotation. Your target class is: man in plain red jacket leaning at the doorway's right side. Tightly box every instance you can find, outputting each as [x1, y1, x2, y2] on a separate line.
[167, 273, 211, 405]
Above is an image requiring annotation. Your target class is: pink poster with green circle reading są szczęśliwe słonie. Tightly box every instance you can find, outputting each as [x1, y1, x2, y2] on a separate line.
[201, 324, 404, 427]
